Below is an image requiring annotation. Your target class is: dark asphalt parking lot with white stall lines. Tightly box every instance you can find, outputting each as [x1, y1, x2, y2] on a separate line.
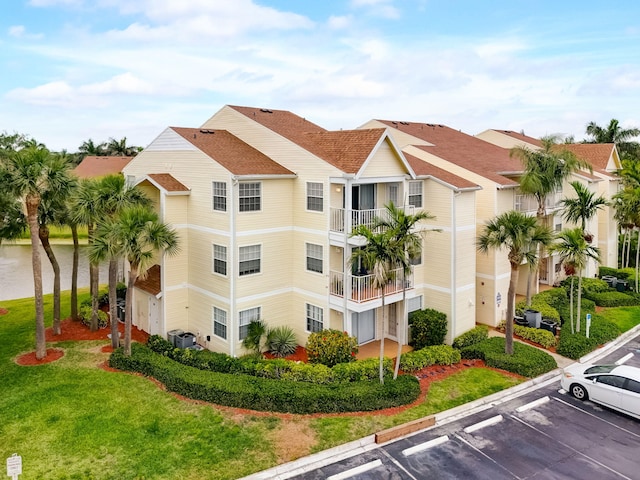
[293, 338, 640, 480]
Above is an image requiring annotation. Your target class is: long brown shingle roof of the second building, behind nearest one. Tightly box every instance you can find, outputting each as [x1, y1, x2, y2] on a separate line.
[378, 120, 523, 187]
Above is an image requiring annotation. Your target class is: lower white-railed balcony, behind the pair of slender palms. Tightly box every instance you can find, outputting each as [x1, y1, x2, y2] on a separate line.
[329, 268, 414, 303]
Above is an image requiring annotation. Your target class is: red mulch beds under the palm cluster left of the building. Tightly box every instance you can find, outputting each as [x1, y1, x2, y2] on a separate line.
[16, 318, 149, 365]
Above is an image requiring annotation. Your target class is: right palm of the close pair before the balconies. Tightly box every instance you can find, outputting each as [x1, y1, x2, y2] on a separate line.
[373, 202, 435, 380]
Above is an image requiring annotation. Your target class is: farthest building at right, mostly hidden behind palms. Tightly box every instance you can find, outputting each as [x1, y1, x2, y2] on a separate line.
[476, 129, 622, 276]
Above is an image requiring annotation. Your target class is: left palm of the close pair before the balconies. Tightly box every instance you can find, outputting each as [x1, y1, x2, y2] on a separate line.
[349, 224, 403, 384]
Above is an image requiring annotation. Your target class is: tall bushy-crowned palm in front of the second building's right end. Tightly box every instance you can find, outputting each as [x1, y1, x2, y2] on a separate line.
[509, 136, 592, 305]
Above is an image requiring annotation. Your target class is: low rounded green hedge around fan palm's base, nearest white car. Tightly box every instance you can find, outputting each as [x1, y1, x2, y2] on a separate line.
[460, 337, 558, 377]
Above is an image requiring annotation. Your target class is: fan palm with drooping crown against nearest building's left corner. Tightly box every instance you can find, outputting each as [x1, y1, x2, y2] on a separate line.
[89, 206, 179, 355]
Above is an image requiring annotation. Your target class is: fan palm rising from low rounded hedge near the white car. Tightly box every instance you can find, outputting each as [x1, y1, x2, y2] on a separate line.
[477, 210, 553, 355]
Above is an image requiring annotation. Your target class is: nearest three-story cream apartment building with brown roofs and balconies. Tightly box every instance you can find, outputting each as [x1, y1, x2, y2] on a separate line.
[124, 106, 484, 355]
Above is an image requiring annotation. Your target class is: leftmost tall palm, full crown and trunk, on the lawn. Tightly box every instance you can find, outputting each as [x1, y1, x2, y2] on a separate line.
[2, 145, 66, 360]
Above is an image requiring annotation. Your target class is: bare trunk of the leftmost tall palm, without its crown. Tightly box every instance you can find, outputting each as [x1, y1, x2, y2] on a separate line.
[25, 195, 47, 360]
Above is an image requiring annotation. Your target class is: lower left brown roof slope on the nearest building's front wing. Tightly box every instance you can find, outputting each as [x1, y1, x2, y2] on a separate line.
[171, 127, 293, 175]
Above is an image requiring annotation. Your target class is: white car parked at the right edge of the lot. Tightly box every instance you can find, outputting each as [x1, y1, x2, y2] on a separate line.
[560, 364, 640, 419]
